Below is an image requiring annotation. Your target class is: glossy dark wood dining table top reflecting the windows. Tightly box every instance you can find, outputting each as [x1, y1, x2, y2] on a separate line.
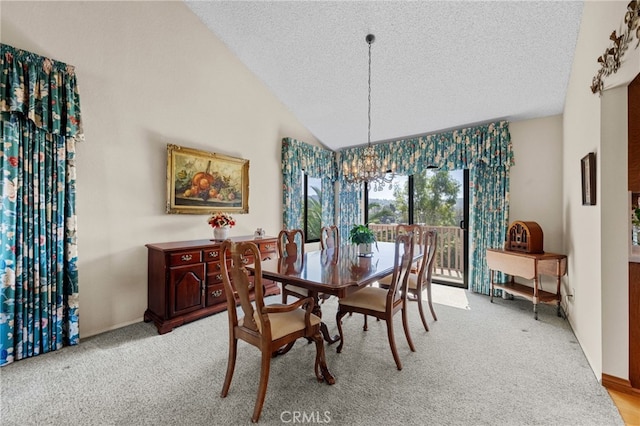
[255, 242, 420, 297]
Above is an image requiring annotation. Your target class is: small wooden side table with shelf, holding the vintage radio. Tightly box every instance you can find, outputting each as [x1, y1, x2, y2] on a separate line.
[487, 249, 567, 319]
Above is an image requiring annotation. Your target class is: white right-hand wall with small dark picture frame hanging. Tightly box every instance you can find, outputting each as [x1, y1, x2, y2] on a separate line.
[562, 0, 638, 379]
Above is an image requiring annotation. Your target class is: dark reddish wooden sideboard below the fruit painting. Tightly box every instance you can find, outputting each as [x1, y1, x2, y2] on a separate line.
[144, 236, 280, 334]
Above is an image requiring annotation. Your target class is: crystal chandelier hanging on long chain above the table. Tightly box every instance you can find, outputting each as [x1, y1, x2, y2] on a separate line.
[343, 34, 395, 191]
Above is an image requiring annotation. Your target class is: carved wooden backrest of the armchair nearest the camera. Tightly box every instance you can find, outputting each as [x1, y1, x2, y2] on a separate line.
[220, 240, 265, 332]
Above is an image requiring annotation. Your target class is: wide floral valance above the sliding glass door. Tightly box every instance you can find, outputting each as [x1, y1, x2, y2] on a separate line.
[337, 121, 513, 177]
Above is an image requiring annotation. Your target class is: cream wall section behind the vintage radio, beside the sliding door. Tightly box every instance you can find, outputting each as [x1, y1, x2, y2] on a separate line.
[509, 115, 570, 294]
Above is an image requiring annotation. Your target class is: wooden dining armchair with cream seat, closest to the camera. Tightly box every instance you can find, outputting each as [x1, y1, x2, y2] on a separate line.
[220, 240, 335, 423]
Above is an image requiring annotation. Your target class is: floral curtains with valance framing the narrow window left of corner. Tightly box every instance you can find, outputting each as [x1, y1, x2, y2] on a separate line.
[282, 138, 336, 233]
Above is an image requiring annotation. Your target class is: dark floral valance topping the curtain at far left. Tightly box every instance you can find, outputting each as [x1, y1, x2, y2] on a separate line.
[0, 44, 84, 140]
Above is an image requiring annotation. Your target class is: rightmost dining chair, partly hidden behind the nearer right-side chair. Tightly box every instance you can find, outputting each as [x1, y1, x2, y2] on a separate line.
[378, 225, 438, 331]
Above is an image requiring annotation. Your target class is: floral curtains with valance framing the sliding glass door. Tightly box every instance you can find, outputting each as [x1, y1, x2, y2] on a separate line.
[336, 121, 514, 294]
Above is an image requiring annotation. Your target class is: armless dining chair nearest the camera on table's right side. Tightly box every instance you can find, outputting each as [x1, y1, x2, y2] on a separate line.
[336, 232, 416, 370]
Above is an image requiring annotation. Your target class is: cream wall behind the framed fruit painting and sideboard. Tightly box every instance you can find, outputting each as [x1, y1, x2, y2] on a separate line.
[1, 2, 318, 337]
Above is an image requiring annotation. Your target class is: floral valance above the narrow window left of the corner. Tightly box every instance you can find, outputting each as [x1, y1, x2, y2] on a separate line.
[282, 138, 336, 182]
